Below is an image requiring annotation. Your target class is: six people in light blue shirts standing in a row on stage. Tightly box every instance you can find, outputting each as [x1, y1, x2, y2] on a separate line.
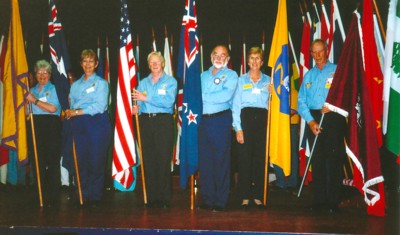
[23, 40, 345, 215]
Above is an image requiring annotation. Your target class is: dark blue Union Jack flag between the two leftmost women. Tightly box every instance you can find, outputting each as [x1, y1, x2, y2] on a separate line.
[48, 0, 70, 110]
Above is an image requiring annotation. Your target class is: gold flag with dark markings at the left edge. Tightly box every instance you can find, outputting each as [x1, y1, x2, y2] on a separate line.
[1, 0, 28, 162]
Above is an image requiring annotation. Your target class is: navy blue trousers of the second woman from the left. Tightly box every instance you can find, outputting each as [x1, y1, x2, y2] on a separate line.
[71, 112, 111, 201]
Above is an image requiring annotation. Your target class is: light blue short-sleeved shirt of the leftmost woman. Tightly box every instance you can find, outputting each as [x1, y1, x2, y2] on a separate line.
[31, 82, 61, 116]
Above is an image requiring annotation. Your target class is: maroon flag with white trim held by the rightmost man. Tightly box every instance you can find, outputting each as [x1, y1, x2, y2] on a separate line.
[326, 13, 385, 216]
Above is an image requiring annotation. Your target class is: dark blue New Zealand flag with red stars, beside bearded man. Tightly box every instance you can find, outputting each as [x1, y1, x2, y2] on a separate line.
[176, 0, 203, 188]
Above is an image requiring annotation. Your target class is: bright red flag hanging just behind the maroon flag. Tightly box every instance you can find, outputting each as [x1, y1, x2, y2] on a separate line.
[362, 0, 383, 146]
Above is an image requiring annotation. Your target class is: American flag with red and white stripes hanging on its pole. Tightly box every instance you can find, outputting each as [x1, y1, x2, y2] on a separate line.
[112, 0, 137, 188]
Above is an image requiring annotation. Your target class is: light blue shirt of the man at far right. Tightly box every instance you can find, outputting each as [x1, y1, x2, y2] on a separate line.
[298, 61, 336, 123]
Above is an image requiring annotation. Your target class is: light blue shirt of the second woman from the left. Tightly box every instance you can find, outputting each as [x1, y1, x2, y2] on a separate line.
[69, 73, 108, 116]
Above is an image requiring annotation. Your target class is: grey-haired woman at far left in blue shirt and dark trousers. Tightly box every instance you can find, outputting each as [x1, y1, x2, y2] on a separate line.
[26, 60, 61, 207]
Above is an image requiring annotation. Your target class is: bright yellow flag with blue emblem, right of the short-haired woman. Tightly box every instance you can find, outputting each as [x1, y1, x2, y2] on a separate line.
[268, 0, 290, 175]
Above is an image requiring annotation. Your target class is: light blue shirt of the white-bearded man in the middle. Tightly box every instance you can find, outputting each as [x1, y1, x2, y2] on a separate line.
[201, 66, 238, 114]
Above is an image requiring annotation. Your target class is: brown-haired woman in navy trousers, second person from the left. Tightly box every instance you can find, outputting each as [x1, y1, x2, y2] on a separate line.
[65, 49, 111, 207]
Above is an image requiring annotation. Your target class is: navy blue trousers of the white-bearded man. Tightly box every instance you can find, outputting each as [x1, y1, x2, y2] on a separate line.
[198, 110, 232, 207]
